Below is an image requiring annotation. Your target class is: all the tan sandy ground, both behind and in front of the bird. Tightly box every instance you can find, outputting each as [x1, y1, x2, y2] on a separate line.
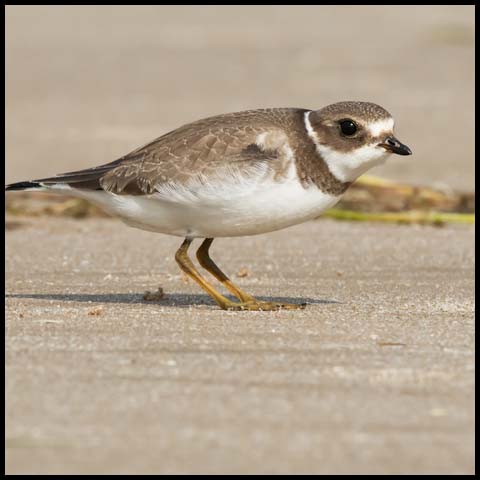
[5, 6, 475, 473]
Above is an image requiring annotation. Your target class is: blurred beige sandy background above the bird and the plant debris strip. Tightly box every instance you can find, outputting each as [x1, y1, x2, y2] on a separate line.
[5, 5, 475, 190]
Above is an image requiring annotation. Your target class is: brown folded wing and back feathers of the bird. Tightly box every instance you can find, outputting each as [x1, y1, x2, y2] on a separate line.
[31, 110, 300, 195]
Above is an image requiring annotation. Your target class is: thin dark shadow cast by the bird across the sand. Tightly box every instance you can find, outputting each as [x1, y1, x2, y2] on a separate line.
[5, 293, 341, 308]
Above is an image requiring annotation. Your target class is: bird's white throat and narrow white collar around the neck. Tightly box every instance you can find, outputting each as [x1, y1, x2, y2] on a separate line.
[305, 112, 390, 182]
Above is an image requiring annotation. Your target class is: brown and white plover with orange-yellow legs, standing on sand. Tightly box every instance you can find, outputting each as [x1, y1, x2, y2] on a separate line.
[5, 101, 412, 311]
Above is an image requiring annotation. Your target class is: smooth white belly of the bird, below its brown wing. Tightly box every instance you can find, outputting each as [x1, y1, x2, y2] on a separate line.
[58, 174, 340, 238]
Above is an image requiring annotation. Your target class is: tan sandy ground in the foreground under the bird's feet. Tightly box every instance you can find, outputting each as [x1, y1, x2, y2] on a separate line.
[6, 218, 474, 474]
